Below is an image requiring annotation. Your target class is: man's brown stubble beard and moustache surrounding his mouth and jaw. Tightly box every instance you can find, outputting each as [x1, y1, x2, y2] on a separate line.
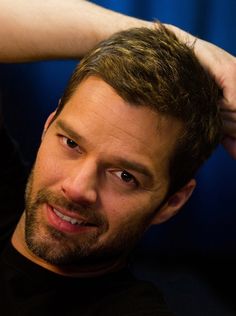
[25, 170, 149, 266]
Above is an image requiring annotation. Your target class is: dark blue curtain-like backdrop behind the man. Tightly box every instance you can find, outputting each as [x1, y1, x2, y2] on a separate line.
[0, 0, 236, 256]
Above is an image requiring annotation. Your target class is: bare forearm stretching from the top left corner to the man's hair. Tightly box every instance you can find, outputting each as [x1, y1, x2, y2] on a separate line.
[0, 0, 150, 62]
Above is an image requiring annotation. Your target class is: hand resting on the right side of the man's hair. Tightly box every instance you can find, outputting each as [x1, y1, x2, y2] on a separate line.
[168, 25, 236, 159]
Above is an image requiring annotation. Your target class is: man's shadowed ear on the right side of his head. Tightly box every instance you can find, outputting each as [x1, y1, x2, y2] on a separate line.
[151, 179, 196, 225]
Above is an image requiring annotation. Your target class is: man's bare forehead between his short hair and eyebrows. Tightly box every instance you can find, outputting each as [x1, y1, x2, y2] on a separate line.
[56, 77, 181, 184]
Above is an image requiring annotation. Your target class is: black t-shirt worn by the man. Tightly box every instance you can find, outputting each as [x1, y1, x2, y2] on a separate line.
[0, 127, 171, 316]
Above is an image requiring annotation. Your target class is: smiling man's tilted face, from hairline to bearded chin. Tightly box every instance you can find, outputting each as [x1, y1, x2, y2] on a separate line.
[26, 77, 180, 265]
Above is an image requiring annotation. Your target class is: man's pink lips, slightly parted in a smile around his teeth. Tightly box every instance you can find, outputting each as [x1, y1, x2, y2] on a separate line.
[46, 205, 95, 234]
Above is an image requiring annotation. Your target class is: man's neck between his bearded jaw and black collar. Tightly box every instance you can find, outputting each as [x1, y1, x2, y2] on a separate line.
[11, 213, 126, 278]
